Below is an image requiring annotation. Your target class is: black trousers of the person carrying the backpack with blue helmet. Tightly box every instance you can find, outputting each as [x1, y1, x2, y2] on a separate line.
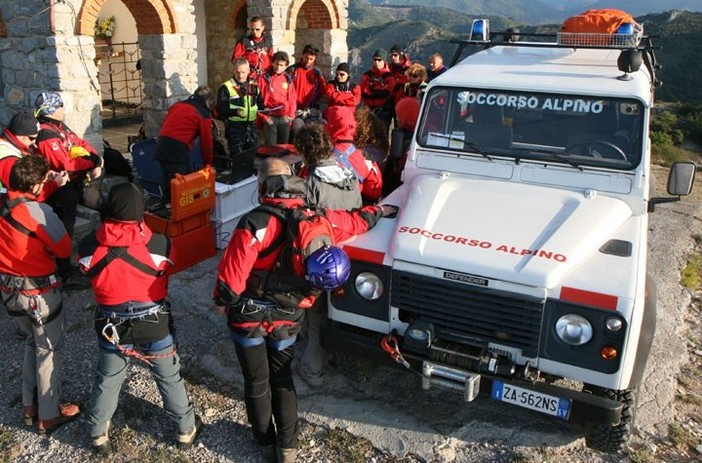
[235, 342, 299, 449]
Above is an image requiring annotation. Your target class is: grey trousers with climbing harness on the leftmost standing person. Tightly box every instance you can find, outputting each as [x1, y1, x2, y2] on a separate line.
[2, 288, 66, 420]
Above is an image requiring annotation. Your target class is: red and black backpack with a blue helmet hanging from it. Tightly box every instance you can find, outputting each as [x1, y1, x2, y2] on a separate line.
[246, 204, 335, 309]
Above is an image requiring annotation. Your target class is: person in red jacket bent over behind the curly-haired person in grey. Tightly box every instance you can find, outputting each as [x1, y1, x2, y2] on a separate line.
[324, 106, 383, 204]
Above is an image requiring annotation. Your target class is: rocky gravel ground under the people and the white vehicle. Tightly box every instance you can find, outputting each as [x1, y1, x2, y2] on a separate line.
[0, 171, 702, 463]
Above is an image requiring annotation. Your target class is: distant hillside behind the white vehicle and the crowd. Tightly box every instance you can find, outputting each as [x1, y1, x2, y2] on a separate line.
[348, 0, 702, 103]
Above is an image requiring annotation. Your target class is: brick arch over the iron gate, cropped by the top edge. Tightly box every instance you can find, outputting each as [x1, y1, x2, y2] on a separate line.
[76, 0, 178, 36]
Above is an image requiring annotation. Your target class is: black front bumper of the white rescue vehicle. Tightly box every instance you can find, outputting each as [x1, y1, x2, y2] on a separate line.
[322, 325, 623, 425]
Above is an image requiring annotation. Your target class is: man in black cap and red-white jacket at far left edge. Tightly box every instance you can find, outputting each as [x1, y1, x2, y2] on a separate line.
[0, 109, 68, 201]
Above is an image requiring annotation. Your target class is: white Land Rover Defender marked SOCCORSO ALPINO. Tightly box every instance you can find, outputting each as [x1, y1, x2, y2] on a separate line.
[324, 20, 695, 452]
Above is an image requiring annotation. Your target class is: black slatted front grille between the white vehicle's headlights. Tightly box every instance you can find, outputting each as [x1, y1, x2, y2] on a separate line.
[390, 270, 544, 357]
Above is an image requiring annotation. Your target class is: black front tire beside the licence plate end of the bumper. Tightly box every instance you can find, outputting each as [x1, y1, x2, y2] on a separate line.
[583, 386, 638, 453]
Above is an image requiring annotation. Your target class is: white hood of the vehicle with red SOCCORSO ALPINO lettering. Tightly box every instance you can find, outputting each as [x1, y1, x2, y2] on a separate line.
[390, 175, 631, 288]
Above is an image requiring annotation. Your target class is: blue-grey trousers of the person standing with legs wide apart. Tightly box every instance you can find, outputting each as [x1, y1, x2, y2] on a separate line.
[86, 345, 195, 437]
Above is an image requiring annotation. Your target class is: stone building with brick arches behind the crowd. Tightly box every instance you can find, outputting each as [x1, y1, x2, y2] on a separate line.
[0, 0, 348, 150]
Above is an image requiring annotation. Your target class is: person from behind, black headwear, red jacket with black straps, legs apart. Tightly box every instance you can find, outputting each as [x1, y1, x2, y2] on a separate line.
[78, 183, 202, 453]
